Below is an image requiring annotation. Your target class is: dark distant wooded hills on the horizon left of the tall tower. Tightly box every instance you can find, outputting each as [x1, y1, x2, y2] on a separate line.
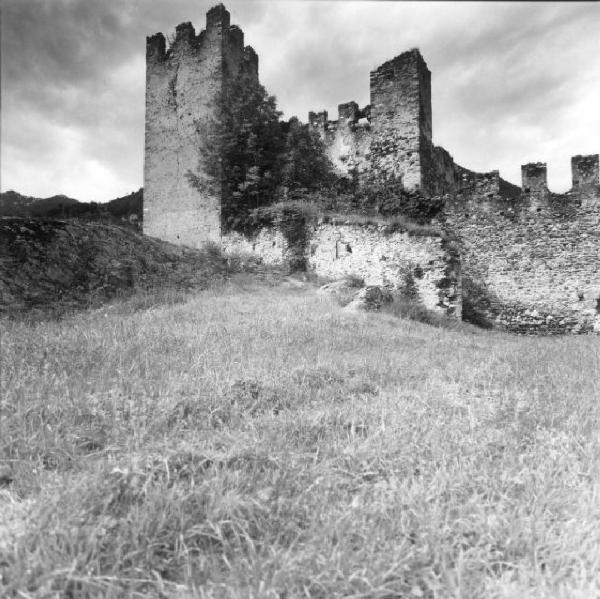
[0, 188, 143, 226]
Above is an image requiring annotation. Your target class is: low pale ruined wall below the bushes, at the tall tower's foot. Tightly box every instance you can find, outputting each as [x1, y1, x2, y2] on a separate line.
[223, 222, 461, 318]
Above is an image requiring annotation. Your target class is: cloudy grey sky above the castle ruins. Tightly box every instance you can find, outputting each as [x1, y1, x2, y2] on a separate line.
[0, 0, 600, 202]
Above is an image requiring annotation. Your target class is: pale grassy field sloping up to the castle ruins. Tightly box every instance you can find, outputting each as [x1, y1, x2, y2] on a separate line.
[0, 275, 600, 599]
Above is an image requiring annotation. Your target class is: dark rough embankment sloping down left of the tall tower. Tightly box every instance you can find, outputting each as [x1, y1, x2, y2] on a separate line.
[0, 218, 226, 315]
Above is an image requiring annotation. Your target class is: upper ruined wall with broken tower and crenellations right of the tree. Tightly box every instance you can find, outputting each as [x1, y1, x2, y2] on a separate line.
[308, 48, 519, 195]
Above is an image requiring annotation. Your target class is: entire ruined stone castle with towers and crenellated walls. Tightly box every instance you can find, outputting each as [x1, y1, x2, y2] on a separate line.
[144, 4, 600, 333]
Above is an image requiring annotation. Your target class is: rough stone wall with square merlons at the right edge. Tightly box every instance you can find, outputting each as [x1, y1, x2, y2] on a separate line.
[445, 157, 600, 333]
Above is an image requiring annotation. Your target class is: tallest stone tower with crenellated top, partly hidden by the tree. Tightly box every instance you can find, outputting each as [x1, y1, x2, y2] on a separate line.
[144, 4, 258, 247]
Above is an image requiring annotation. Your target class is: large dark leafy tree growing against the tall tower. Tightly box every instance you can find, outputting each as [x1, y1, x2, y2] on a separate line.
[186, 76, 333, 232]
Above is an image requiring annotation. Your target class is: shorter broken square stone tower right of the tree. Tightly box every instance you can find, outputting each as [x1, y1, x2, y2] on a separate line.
[370, 48, 434, 193]
